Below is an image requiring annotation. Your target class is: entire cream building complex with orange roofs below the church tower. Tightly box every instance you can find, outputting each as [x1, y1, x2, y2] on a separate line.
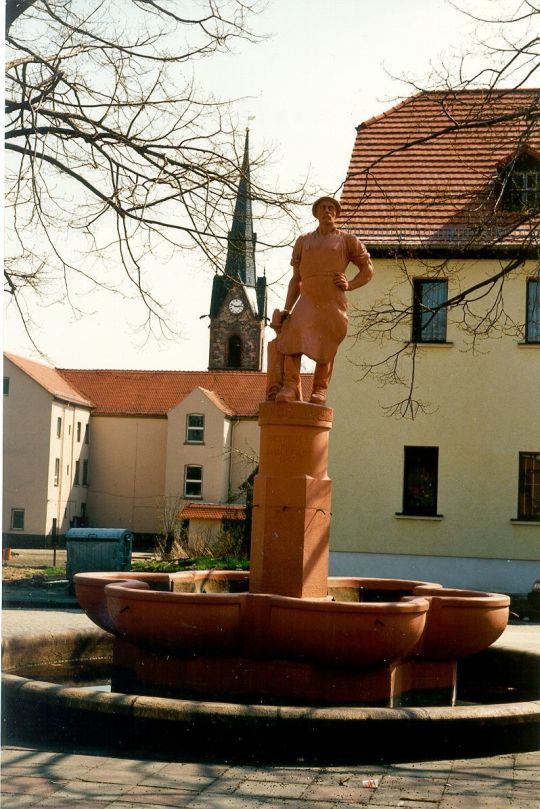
[3, 355, 311, 547]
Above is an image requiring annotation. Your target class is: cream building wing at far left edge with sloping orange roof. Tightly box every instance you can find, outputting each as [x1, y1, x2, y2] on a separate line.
[3, 354, 92, 547]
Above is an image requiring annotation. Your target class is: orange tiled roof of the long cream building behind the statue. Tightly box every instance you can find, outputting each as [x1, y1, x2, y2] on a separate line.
[58, 368, 312, 417]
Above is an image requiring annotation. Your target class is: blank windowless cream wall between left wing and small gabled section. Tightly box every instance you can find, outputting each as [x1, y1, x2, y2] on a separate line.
[88, 416, 167, 534]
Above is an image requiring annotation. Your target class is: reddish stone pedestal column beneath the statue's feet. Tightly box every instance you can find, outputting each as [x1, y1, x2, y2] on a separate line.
[250, 402, 332, 598]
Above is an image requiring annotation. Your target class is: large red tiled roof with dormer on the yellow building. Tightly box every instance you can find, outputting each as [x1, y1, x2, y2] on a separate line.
[339, 89, 540, 249]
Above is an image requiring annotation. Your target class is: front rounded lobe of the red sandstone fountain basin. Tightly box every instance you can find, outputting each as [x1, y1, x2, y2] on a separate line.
[104, 581, 429, 666]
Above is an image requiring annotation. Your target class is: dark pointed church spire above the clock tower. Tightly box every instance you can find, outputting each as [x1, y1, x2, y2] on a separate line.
[225, 129, 257, 287]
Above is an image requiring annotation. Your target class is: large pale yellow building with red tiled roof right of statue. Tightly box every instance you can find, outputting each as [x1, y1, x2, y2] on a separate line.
[330, 90, 540, 592]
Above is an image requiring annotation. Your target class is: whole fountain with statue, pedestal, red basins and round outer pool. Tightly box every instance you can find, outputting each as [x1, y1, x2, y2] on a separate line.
[3, 198, 540, 761]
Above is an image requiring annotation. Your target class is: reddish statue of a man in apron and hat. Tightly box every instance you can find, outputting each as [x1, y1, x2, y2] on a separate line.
[267, 197, 373, 404]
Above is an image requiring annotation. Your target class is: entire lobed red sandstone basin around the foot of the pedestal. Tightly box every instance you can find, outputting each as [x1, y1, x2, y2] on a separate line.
[75, 571, 509, 667]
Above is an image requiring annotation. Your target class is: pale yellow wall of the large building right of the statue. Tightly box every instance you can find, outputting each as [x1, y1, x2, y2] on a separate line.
[329, 260, 540, 589]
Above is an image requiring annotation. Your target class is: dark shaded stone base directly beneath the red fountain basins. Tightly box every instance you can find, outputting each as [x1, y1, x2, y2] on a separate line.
[112, 638, 457, 708]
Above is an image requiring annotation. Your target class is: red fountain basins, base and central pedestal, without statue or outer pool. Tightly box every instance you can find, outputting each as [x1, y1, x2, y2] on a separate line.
[71, 402, 509, 707]
